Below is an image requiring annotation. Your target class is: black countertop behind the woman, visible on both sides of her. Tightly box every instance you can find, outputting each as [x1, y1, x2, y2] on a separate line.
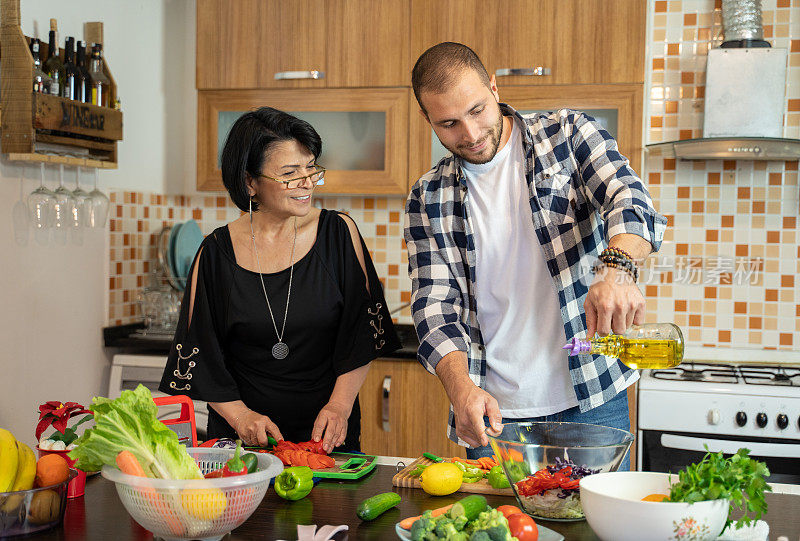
[103, 323, 419, 360]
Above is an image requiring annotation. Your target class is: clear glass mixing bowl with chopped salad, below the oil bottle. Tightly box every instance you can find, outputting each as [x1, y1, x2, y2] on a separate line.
[486, 422, 633, 521]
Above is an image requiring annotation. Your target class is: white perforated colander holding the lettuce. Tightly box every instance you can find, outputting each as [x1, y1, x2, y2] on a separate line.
[102, 447, 283, 540]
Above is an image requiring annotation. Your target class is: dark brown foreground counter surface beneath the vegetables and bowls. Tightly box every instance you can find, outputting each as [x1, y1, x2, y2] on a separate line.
[34, 465, 800, 541]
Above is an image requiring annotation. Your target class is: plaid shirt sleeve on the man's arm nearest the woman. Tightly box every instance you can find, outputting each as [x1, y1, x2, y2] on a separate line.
[404, 171, 469, 374]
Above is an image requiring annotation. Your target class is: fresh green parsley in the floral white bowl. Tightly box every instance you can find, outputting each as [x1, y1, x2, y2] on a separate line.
[669, 447, 772, 532]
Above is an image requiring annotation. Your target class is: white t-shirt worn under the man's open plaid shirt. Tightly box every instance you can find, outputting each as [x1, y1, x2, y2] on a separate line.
[463, 122, 578, 418]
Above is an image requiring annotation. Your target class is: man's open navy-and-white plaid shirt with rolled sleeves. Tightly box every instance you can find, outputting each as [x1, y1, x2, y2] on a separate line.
[405, 104, 667, 445]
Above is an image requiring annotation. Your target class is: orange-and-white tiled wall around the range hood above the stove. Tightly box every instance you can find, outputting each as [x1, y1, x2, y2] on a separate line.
[643, 0, 800, 350]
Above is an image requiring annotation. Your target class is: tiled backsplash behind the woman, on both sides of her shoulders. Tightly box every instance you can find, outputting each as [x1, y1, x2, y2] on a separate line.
[108, 192, 411, 325]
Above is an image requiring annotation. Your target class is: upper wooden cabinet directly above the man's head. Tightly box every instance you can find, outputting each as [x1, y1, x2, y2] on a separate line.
[411, 0, 646, 86]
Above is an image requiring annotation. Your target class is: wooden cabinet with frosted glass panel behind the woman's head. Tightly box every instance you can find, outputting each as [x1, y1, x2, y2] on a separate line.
[197, 88, 410, 195]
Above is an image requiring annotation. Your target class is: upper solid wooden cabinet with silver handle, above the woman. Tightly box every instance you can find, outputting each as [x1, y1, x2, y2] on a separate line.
[197, 0, 411, 89]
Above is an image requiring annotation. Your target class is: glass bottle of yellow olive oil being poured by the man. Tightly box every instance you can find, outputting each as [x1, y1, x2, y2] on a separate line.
[563, 323, 683, 370]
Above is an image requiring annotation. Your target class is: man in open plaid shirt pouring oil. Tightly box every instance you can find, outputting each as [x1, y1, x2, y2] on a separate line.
[405, 43, 666, 464]
